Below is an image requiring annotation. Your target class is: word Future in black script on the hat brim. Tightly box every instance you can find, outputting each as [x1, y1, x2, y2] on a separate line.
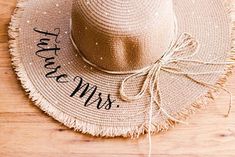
[34, 28, 68, 83]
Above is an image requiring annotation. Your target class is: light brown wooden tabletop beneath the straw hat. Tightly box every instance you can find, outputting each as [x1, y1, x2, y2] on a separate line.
[0, 0, 235, 157]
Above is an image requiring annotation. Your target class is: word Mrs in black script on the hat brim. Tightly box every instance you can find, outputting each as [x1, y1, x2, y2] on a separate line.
[70, 76, 116, 110]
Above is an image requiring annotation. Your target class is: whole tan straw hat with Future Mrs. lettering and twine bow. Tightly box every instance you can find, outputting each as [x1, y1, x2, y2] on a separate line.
[9, 0, 233, 137]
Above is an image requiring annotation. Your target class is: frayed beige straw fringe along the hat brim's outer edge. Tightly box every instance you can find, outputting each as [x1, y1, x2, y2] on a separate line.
[9, 0, 235, 138]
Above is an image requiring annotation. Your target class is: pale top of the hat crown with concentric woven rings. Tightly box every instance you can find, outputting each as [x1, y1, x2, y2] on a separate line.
[71, 0, 169, 35]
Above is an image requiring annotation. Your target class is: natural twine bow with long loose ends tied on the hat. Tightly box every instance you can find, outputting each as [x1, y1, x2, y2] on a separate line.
[120, 33, 233, 156]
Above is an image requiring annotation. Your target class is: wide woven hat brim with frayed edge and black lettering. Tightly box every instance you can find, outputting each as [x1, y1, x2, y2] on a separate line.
[9, 0, 232, 137]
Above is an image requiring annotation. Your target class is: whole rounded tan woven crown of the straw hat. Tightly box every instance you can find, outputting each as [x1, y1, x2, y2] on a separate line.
[72, 0, 174, 71]
